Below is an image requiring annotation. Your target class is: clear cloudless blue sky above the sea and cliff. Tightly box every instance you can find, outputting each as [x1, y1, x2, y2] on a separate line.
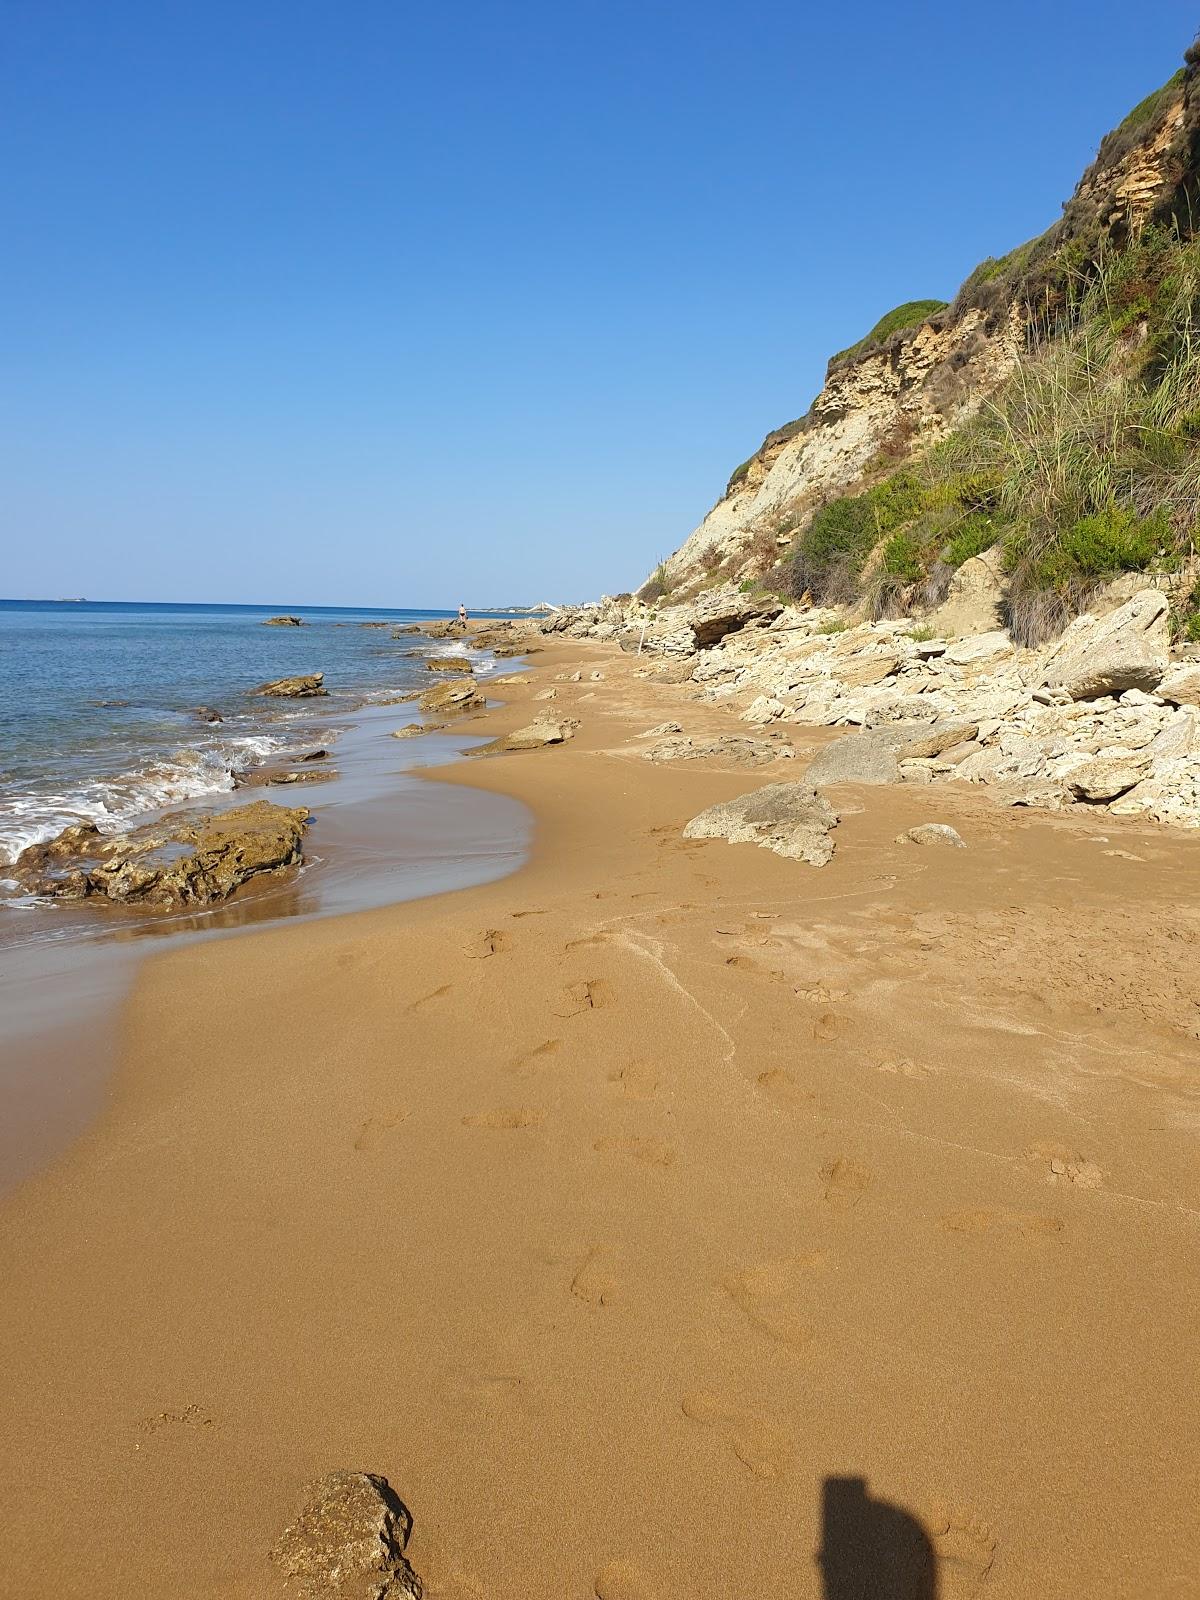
[0, 0, 1198, 605]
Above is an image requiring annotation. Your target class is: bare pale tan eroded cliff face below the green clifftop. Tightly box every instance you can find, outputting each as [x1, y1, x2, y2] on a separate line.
[652, 67, 1200, 594]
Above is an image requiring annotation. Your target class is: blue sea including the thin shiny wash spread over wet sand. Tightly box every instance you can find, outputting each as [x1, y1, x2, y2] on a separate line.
[0, 600, 533, 1192]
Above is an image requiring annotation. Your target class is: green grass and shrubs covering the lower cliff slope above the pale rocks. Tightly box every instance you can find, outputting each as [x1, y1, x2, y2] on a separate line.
[771, 227, 1200, 643]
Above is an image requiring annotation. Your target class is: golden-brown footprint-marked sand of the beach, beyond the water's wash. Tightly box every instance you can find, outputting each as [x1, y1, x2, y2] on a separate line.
[0, 630, 1200, 1600]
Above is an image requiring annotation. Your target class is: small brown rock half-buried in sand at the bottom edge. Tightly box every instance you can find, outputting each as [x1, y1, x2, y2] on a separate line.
[270, 1472, 422, 1600]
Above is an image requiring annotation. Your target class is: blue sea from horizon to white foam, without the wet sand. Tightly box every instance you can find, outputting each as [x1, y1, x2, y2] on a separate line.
[0, 600, 499, 893]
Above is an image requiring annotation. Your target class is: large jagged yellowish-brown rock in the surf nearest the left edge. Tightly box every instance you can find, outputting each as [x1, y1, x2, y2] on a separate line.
[6, 806, 315, 909]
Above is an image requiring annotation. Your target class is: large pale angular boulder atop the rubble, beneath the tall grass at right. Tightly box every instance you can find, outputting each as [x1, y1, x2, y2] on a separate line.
[1042, 589, 1171, 701]
